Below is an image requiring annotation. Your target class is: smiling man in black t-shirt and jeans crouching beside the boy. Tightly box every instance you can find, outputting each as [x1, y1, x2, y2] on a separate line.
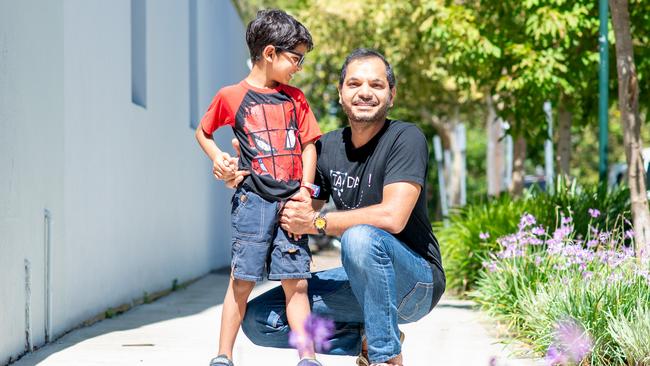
[225, 49, 445, 365]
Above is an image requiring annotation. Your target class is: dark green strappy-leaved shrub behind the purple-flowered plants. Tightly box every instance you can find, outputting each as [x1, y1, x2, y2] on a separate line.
[434, 178, 630, 294]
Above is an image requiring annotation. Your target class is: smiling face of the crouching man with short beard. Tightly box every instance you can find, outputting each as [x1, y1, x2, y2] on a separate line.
[339, 57, 395, 123]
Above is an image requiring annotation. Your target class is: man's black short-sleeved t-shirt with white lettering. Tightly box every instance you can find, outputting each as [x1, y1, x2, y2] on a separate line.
[316, 120, 443, 271]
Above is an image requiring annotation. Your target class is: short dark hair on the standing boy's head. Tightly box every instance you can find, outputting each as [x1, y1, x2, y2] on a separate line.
[246, 9, 314, 63]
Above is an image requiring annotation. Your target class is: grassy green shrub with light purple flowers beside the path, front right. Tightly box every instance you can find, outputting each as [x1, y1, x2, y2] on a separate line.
[472, 207, 650, 365]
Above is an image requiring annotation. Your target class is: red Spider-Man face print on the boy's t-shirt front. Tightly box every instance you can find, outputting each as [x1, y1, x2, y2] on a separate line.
[237, 94, 302, 183]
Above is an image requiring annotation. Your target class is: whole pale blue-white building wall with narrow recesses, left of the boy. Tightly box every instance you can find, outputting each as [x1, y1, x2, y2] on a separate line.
[0, 0, 248, 365]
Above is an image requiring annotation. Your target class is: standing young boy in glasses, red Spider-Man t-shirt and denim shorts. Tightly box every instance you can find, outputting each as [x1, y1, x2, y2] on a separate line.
[196, 10, 321, 366]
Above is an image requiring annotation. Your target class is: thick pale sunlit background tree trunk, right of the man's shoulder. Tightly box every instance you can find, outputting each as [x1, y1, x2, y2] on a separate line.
[486, 95, 505, 196]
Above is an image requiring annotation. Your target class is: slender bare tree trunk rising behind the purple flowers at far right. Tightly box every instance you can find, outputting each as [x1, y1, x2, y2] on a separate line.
[609, 0, 650, 255]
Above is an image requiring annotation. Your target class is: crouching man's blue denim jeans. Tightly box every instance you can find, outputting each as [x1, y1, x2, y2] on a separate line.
[242, 225, 445, 362]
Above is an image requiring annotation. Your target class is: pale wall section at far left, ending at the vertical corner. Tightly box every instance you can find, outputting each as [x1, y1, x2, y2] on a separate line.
[0, 0, 64, 364]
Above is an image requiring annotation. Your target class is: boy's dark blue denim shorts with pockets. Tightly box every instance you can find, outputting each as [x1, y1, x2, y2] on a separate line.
[231, 185, 311, 281]
